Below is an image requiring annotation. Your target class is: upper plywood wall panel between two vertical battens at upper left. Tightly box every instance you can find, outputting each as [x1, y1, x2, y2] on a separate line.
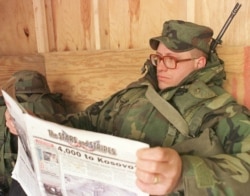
[48, 0, 95, 51]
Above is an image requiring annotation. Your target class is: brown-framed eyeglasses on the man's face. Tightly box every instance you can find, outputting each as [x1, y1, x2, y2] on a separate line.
[149, 54, 198, 69]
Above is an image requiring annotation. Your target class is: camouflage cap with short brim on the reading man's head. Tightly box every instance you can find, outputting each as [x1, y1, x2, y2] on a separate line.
[149, 20, 213, 53]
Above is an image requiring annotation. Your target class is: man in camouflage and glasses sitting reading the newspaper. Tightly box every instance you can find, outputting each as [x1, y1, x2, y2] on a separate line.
[6, 20, 250, 196]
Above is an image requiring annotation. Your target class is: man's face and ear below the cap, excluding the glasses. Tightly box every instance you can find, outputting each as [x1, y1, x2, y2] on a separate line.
[156, 43, 203, 90]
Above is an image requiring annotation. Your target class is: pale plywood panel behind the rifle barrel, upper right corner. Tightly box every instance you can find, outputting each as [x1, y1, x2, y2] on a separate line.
[195, 0, 250, 46]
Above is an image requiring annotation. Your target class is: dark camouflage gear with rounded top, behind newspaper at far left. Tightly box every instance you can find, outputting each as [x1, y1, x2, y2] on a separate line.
[0, 70, 66, 196]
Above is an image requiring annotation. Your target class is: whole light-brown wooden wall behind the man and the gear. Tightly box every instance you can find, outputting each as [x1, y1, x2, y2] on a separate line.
[0, 0, 250, 108]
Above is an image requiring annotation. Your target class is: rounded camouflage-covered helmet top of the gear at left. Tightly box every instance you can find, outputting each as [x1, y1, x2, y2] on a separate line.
[13, 70, 50, 94]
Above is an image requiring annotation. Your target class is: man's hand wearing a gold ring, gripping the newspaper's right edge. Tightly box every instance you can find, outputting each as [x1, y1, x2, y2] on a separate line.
[136, 147, 182, 195]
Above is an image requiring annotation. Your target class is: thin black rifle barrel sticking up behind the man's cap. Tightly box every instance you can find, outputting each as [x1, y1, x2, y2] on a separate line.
[210, 3, 241, 53]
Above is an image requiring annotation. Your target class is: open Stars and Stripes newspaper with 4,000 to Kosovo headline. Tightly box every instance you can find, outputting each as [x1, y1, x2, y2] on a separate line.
[2, 90, 148, 196]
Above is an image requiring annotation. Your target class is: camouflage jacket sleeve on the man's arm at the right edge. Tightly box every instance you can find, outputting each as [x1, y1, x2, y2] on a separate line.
[175, 107, 250, 196]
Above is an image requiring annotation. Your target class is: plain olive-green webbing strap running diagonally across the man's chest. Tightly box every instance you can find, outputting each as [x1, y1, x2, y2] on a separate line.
[146, 86, 190, 137]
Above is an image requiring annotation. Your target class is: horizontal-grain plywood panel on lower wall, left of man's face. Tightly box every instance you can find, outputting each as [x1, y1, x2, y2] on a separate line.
[45, 49, 151, 111]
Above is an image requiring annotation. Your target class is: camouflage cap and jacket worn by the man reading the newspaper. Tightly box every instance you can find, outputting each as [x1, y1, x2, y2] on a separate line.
[53, 21, 250, 196]
